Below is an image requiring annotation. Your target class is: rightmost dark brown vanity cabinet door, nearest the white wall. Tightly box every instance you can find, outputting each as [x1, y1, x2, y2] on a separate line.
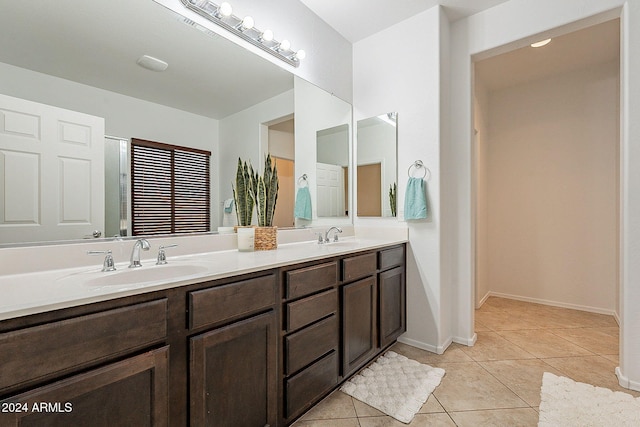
[378, 267, 407, 348]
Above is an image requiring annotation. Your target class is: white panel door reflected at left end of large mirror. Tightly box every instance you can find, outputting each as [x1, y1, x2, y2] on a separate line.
[0, 95, 104, 244]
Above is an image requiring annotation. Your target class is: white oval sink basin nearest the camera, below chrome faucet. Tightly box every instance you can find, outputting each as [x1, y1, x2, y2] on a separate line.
[85, 264, 208, 287]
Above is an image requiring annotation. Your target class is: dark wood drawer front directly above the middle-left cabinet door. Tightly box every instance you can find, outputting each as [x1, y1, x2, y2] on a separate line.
[189, 274, 276, 329]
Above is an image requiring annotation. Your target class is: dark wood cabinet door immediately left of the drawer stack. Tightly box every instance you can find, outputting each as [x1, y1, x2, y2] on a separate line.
[189, 311, 278, 427]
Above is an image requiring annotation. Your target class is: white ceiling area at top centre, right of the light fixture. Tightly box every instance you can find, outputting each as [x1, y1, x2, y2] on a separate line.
[300, 0, 508, 43]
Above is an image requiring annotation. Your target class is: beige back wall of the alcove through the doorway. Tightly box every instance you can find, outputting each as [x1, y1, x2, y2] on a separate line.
[476, 62, 620, 314]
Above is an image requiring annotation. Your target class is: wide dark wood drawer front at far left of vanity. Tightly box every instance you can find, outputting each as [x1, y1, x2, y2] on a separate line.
[0, 299, 167, 389]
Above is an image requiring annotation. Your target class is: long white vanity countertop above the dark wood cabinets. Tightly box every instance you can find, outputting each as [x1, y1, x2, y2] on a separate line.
[0, 236, 407, 320]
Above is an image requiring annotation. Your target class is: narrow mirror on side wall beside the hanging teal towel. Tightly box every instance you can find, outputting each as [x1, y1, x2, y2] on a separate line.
[356, 112, 398, 217]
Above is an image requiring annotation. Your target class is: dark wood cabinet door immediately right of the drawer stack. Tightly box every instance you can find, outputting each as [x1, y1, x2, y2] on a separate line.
[342, 276, 377, 376]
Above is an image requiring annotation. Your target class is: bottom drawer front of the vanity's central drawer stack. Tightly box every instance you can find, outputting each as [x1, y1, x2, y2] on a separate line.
[286, 351, 338, 418]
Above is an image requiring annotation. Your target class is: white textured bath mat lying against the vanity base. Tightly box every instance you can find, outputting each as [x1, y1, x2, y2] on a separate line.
[340, 351, 444, 424]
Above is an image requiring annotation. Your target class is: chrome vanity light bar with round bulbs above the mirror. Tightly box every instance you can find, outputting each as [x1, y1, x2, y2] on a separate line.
[180, 0, 306, 67]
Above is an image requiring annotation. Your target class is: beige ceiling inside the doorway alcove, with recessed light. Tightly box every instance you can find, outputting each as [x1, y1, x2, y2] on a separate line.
[475, 19, 620, 90]
